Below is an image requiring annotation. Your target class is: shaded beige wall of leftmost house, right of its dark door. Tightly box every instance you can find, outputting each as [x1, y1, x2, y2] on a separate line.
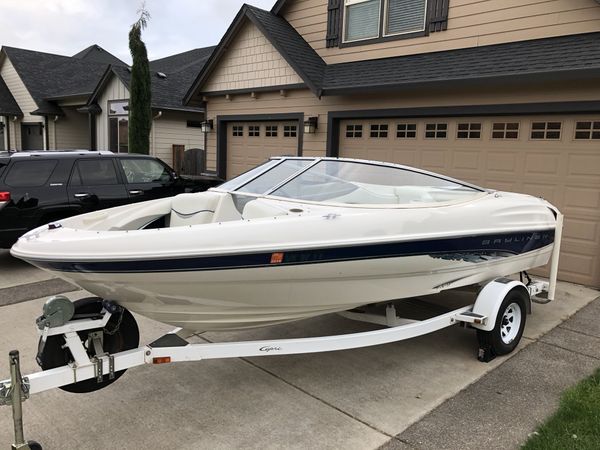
[50, 107, 90, 150]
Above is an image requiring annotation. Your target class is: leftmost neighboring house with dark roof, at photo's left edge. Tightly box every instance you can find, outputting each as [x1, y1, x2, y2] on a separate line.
[0, 45, 125, 150]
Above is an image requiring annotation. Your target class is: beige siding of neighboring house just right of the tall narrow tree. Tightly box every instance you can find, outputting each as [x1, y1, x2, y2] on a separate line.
[150, 111, 204, 166]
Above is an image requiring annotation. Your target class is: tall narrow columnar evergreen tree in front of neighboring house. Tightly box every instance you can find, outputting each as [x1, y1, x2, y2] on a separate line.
[129, 4, 152, 155]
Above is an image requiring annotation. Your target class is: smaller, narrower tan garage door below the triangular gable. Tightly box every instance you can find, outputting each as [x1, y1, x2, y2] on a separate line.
[227, 121, 299, 178]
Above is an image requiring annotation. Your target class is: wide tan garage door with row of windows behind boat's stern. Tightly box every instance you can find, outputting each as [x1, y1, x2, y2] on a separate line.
[340, 116, 600, 287]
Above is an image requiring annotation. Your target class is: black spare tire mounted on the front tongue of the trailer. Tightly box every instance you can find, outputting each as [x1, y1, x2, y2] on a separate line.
[38, 297, 140, 393]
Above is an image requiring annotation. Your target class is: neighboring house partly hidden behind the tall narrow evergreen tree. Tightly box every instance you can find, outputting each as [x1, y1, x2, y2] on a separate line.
[87, 47, 214, 170]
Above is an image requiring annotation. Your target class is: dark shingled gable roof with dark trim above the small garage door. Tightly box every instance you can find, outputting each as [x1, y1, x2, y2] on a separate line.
[184, 5, 325, 103]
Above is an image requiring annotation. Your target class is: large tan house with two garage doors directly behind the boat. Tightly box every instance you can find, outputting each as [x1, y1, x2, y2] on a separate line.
[186, 0, 600, 287]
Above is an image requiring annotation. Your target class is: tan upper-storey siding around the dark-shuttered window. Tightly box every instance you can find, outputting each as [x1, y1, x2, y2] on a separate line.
[284, 0, 600, 64]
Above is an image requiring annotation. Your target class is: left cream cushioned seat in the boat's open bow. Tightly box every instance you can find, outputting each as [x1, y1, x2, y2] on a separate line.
[169, 192, 222, 227]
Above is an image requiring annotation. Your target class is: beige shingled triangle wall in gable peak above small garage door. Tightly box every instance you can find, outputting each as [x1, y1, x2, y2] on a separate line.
[203, 21, 303, 92]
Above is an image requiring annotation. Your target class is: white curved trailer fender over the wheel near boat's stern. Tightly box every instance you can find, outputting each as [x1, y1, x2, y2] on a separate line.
[471, 278, 531, 331]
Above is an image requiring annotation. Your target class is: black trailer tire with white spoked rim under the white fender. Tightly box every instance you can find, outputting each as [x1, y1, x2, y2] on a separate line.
[477, 289, 527, 358]
